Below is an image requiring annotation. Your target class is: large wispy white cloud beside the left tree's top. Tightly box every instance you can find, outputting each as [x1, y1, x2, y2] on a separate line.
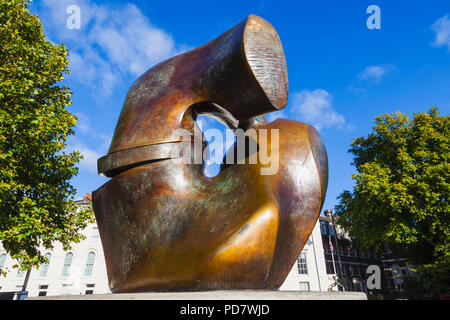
[42, 0, 185, 96]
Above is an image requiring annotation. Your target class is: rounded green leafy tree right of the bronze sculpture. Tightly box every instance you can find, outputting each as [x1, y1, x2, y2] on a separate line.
[335, 107, 450, 297]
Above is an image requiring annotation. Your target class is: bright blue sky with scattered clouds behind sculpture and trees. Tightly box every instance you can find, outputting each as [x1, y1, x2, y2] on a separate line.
[30, 0, 450, 215]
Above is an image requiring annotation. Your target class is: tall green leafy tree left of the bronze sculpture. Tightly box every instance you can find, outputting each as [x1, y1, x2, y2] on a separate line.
[0, 0, 93, 276]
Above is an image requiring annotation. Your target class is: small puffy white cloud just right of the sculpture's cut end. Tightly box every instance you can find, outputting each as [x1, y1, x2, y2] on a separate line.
[268, 89, 345, 131]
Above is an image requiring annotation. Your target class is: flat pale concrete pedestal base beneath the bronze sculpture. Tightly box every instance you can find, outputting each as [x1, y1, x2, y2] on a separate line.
[27, 290, 367, 300]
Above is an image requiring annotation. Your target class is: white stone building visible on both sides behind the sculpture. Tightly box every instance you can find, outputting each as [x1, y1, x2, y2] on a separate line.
[0, 195, 330, 297]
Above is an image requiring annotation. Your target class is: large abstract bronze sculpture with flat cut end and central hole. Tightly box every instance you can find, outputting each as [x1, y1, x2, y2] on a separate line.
[93, 15, 328, 292]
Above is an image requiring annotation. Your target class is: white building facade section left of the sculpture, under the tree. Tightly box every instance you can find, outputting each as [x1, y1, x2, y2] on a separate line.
[0, 194, 110, 297]
